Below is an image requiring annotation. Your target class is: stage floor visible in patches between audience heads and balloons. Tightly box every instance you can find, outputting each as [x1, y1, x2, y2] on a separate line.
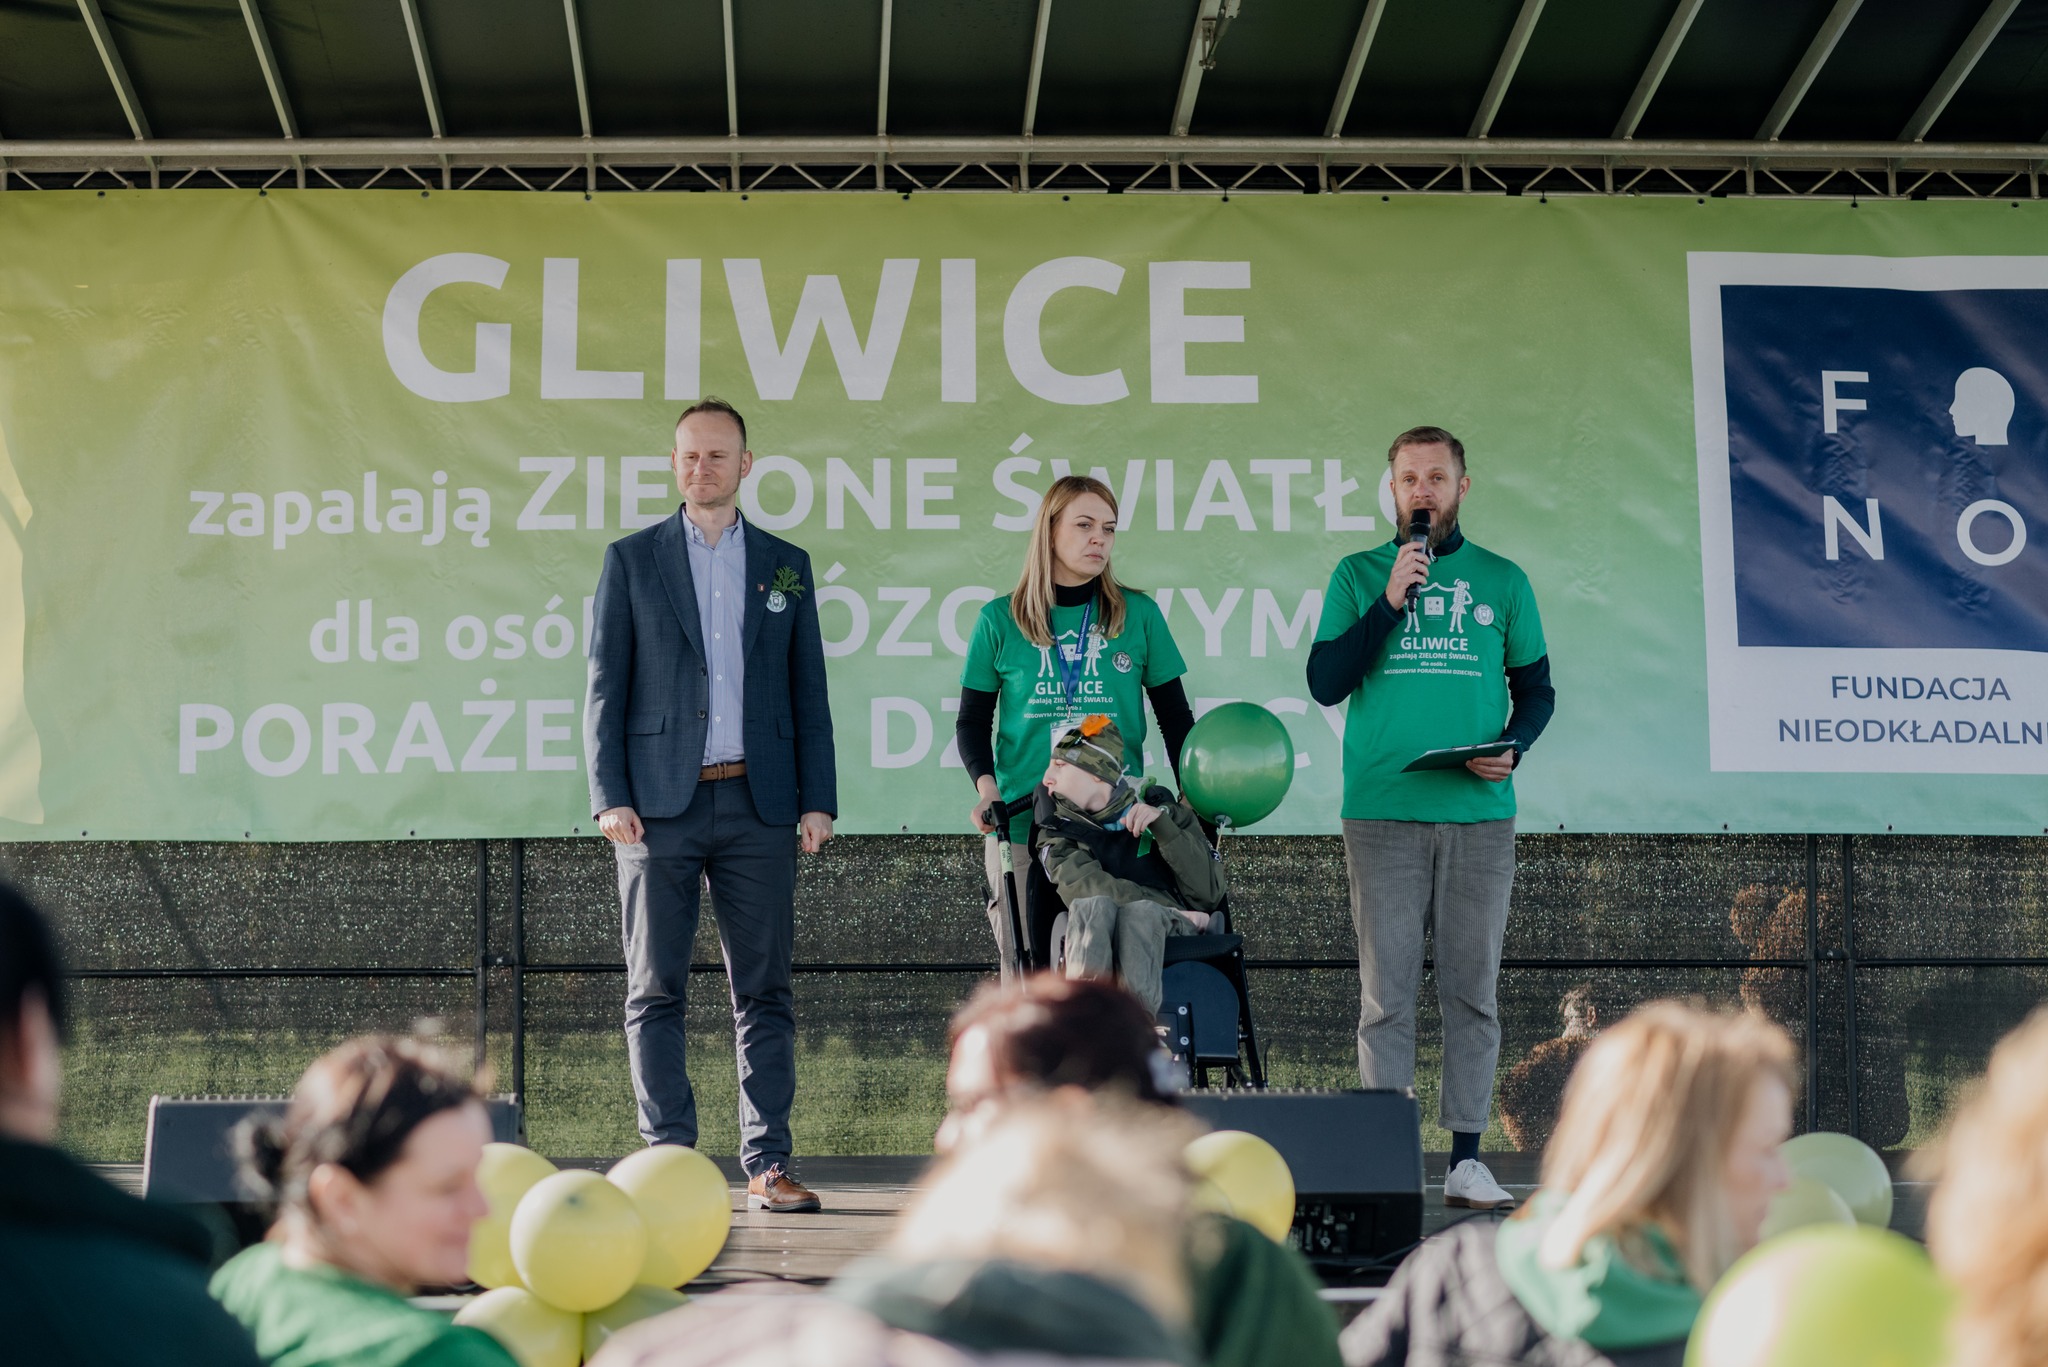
[96, 1154, 1929, 1318]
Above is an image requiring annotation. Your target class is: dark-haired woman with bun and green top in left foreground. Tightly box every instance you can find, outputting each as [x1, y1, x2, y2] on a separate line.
[211, 1035, 514, 1367]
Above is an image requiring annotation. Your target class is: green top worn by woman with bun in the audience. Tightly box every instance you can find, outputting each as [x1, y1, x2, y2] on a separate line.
[207, 1244, 518, 1367]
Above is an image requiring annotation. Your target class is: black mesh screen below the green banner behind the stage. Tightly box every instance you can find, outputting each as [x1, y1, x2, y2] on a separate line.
[0, 834, 2048, 1160]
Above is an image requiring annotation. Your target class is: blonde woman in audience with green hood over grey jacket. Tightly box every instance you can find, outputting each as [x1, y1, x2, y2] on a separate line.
[1341, 1002, 1794, 1367]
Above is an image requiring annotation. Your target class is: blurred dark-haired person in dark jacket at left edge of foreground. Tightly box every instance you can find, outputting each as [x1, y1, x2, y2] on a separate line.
[0, 883, 262, 1367]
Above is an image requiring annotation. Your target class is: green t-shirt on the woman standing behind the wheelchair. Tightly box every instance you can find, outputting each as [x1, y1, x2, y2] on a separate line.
[961, 588, 1188, 838]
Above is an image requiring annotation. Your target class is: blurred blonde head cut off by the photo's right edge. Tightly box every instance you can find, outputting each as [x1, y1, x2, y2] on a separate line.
[1927, 1006, 2048, 1367]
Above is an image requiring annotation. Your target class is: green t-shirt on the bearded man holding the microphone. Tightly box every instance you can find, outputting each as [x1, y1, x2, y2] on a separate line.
[1315, 541, 1546, 822]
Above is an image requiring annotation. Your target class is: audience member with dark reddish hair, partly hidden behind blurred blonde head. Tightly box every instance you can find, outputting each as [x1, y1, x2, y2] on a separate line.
[938, 974, 1337, 1367]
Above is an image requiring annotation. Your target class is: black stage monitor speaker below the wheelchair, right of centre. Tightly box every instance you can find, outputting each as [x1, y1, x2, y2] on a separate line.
[1180, 1088, 1423, 1277]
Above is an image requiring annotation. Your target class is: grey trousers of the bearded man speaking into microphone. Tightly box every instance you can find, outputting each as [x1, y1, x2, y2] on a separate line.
[1343, 818, 1516, 1133]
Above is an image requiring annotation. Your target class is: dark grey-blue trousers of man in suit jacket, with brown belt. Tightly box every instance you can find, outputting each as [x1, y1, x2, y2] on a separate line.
[612, 779, 797, 1176]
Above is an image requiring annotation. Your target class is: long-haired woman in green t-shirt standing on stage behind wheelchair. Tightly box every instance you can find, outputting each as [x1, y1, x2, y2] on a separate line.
[954, 475, 1194, 965]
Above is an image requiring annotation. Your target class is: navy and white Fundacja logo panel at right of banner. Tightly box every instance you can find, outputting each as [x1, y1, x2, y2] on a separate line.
[1688, 252, 2048, 774]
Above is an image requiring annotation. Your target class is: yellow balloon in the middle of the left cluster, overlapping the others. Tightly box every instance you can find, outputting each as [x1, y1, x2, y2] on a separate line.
[512, 1172, 647, 1312]
